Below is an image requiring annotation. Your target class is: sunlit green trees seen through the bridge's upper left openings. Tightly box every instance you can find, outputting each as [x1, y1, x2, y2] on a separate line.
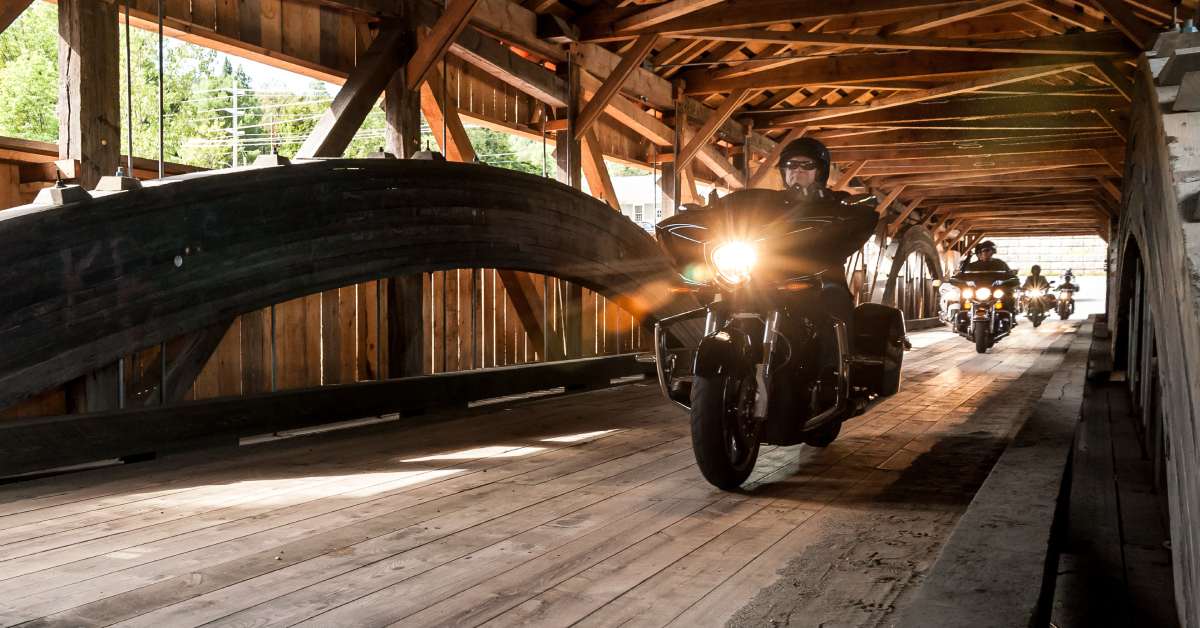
[0, 2, 544, 174]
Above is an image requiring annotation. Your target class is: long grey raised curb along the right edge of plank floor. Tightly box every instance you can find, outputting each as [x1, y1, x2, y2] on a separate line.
[895, 319, 1094, 628]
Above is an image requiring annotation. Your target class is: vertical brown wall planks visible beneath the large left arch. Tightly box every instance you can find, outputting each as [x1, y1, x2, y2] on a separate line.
[164, 269, 650, 400]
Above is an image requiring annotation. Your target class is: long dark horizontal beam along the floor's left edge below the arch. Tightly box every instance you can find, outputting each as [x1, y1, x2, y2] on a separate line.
[0, 351, 646, 476]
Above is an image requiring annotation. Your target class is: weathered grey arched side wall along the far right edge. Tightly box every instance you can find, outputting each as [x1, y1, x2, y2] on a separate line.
[1108, 34, 1200, 626]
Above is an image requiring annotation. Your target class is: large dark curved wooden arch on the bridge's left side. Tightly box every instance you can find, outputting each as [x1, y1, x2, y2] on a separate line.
[0, 160, 683, 407]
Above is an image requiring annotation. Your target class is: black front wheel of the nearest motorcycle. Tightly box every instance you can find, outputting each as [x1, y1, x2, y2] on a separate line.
[691, 375, 758, 491]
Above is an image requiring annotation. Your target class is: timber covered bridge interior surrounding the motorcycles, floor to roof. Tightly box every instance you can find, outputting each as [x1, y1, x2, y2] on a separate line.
[0, 0, 1200, 626]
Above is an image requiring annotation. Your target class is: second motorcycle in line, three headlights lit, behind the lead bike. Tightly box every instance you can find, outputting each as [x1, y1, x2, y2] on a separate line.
[949, 270, 1019, 353]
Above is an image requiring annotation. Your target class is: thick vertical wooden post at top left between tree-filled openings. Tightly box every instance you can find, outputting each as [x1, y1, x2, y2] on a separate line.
[59, 0, 121, 189]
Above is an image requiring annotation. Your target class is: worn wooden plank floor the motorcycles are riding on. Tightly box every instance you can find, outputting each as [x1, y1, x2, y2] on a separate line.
[0, 322, 1078, 627]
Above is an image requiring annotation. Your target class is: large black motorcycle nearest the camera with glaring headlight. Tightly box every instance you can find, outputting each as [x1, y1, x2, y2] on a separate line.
[654, 190, 905, 490]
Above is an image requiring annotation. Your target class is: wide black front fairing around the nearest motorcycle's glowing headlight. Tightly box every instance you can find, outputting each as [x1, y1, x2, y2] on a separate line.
[655, 190, 876, 281]
